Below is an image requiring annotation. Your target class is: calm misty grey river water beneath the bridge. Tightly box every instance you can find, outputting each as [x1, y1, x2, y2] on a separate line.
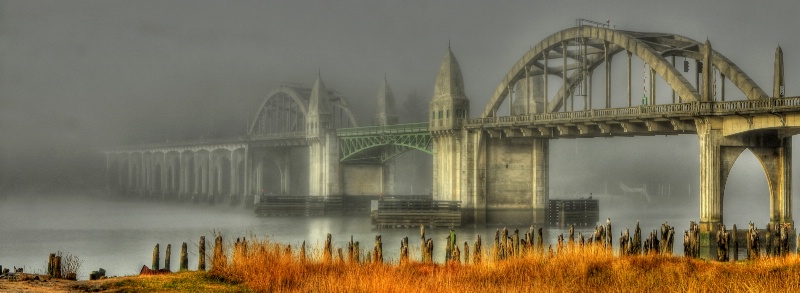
[0, 190, 698, 279]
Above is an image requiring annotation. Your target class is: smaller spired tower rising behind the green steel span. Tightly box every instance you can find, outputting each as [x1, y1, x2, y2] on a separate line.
[373, 77, 398, 195]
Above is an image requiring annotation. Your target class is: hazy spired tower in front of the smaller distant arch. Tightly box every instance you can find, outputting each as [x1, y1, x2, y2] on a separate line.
[306, 76, 341, 196]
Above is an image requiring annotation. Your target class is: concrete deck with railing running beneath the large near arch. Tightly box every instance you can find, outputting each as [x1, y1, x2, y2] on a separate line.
[464, 97, 800, 138]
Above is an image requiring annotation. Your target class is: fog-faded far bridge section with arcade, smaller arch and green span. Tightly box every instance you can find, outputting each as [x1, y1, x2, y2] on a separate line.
[105, 78, 431, 203]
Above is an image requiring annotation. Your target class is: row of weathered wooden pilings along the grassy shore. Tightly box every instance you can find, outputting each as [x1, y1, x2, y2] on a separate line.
[148, 219, 790, 274]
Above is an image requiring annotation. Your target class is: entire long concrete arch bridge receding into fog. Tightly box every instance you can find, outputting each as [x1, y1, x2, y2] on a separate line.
[106, 24, 800, 252]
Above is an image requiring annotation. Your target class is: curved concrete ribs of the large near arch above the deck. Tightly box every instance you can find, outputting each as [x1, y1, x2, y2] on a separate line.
[481, 26, 768, 118]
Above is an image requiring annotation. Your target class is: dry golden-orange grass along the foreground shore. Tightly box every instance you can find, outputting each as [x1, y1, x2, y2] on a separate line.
[211, 240, 800, 292]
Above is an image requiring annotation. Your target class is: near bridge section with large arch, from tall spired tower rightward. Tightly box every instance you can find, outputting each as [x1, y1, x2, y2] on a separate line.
[429, 25, 800, 256]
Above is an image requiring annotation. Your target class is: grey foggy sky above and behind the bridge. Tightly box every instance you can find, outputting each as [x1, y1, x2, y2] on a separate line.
[0, 0, 800, 221]
